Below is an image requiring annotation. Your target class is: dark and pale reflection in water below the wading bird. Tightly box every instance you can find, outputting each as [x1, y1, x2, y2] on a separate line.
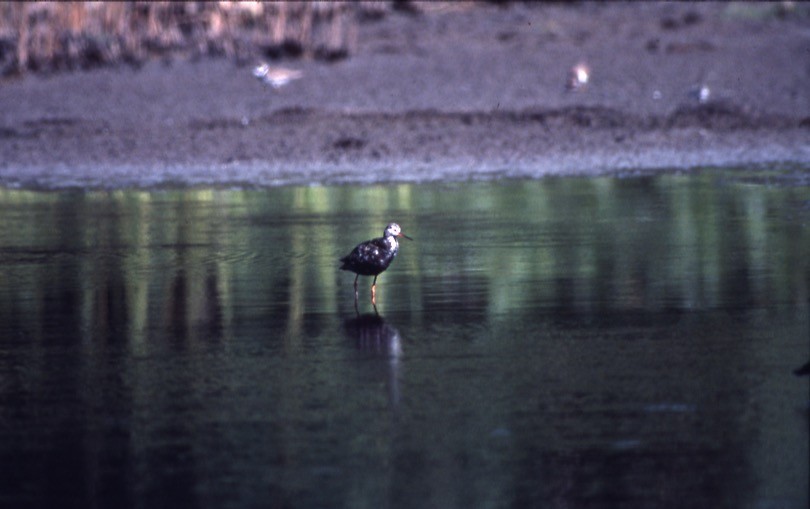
[343, 308, 402, 408]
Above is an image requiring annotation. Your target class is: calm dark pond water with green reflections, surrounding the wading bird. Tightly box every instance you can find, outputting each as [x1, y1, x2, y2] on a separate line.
[0, 171, 810, 508]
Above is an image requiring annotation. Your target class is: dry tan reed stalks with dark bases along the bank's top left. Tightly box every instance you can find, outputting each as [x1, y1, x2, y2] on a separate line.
[0, 1, 400, 75]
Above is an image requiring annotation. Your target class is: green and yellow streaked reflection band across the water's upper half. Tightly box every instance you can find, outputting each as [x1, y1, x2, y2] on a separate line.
[0, 171, 810, 342]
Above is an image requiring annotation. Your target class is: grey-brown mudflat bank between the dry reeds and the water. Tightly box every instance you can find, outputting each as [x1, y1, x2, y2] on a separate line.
[0, 3, 810, 188]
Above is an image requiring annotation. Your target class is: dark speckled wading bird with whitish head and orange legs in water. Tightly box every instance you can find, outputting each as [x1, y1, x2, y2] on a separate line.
[340, 223, 413, 307]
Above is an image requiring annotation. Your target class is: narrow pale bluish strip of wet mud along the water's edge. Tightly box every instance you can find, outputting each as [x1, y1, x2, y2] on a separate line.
[0, 144, 810, 192]
